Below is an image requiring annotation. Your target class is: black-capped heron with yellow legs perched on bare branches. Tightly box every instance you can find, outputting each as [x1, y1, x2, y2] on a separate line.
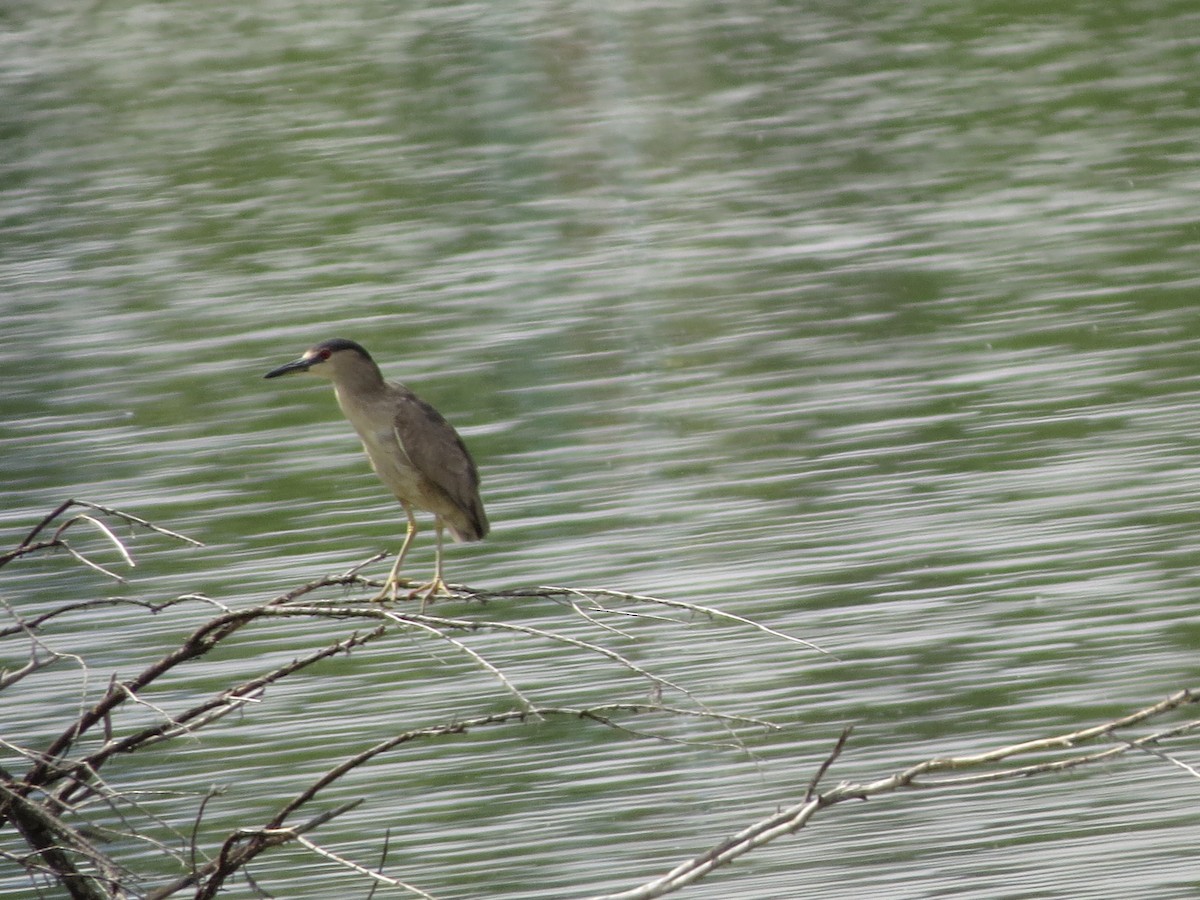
[265, 337, 488, 608]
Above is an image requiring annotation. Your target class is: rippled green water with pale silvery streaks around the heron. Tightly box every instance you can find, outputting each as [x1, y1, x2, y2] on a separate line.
[0, 0, 1200, 898]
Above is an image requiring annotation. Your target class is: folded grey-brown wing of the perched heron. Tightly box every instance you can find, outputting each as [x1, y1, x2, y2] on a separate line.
[395, 385, 488, 540]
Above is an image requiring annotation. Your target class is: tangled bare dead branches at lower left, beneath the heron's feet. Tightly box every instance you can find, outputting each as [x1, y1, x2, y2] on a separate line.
[0, 499, 816, 900]
